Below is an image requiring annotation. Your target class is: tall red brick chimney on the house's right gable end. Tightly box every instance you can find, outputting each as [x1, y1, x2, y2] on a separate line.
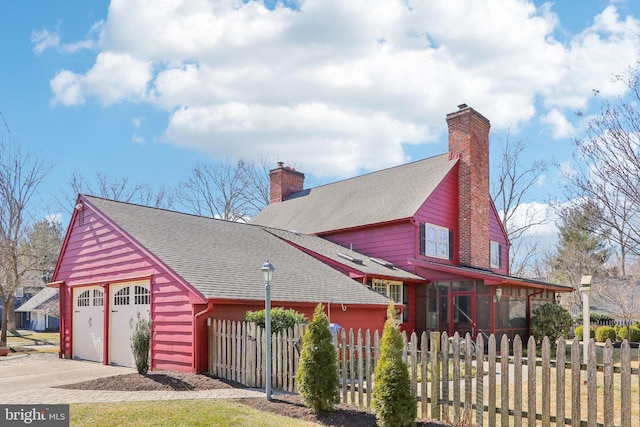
[447, 104, 491, 268]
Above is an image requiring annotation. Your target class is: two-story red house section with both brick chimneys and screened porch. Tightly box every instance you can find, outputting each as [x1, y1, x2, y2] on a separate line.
[253, 104, 571, 346]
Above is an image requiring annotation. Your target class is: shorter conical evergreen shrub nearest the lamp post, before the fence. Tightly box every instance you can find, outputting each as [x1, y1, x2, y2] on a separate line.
[296, 304, 340, 413]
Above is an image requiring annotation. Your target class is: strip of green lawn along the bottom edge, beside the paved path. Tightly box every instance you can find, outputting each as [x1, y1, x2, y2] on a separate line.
[70, 400, 317, 427]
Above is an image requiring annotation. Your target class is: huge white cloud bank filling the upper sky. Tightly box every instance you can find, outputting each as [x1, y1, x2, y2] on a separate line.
[51, 0, 640, 176]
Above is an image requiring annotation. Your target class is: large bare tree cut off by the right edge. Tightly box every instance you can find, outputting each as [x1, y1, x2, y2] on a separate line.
[566, 65, 640, 277]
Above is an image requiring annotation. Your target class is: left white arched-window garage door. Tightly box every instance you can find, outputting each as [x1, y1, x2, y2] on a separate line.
[73, 286, 104, 362]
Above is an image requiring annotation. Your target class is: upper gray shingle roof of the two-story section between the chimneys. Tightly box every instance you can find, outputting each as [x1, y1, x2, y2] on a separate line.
[251, 154, 457, 234]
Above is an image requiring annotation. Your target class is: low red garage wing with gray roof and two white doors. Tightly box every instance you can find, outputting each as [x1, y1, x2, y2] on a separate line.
[49, 195, 424, 372]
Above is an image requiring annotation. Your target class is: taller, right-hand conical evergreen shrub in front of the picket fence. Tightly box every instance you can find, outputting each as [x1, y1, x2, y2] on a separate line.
[372, 302, 417, 427]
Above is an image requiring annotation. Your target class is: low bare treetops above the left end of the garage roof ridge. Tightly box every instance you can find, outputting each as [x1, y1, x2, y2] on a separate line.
[58, 172, 175, 213]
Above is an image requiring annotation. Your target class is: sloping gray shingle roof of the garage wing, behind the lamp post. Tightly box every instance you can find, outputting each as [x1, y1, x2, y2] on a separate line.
[83, 196, 396, 305]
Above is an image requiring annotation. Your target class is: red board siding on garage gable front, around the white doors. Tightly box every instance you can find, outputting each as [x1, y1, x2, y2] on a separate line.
[55, 207, 194, 371]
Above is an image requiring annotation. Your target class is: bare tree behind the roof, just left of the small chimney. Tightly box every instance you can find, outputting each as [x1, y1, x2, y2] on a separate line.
[177, 160, 269, 222]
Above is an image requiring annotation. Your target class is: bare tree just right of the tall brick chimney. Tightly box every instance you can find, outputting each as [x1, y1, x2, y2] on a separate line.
[491, 134, 549, 276]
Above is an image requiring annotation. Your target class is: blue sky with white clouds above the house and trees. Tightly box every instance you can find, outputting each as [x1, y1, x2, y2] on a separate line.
[0, 0, 640, 251]
